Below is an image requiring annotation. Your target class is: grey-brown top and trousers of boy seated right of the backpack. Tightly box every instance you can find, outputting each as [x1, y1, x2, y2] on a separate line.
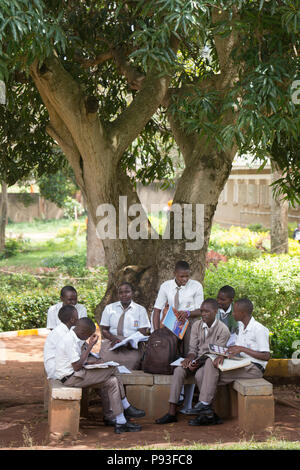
[169, 319, 230, 403]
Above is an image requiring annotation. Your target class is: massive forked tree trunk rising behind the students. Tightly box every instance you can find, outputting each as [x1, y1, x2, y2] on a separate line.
[31, 36, 239, 320]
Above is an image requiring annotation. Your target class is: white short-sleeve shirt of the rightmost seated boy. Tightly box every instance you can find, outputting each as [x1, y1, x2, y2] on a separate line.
[235, 317, 270, 368]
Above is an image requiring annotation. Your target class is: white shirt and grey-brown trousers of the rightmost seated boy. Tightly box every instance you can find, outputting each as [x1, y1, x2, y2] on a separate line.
[191, 317, 270, 403]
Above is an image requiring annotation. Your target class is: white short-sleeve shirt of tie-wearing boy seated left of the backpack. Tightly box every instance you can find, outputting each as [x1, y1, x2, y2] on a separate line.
[100, 301, 150, 338]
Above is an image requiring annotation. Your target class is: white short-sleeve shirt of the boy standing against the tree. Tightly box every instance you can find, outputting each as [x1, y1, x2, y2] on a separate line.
[154, 279, 203, 311]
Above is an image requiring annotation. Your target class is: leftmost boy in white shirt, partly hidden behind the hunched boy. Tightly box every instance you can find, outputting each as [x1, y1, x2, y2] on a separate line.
[44, 305, 78, 379]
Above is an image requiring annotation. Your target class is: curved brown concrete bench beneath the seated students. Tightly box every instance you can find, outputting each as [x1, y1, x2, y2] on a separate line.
[48, 371, 274, 435]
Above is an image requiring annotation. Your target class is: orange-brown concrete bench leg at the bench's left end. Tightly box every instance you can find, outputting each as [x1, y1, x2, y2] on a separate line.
[48, 398, 80, 437]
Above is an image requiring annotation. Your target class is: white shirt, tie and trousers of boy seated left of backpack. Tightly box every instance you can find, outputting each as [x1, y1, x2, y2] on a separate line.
[100, 301, 150, 370]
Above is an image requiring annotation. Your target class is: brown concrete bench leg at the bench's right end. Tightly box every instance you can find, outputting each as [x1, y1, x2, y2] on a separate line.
[238, 393, 274, 432]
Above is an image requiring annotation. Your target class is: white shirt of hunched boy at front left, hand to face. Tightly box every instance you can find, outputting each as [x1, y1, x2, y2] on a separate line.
[55, 329, 84, 379]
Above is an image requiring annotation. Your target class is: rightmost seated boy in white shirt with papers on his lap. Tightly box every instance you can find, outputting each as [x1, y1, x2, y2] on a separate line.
[189, 298, 270, 426]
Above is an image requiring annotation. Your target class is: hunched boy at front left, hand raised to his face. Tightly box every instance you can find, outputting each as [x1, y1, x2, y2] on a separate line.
[55, 318, 145, 434]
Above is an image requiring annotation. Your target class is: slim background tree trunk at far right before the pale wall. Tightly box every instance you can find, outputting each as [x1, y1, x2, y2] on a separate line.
[271, 164, 289, 254]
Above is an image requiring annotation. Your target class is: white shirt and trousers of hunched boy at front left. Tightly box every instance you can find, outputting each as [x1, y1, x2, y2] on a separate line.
[55, 330, 125, 416]
